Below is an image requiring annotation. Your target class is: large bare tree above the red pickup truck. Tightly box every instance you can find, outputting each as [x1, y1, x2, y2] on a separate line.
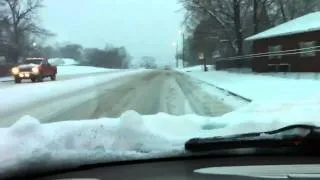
[0, 0, 54, 63]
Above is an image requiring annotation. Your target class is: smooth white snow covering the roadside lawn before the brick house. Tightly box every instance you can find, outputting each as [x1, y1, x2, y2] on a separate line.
[180, 66, 320, 101]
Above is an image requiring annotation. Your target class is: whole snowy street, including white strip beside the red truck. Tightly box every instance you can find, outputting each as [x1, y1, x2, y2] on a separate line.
[0, 67, 242, 126]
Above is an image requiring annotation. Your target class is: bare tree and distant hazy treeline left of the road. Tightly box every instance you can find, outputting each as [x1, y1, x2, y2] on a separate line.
[0, 0, 131, 68]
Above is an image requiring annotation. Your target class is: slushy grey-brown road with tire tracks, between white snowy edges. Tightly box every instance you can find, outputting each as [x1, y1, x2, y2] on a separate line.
[0, 70, 233, 125]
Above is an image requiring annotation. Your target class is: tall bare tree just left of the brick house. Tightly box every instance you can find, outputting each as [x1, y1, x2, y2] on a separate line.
[180, 0, 251, 55]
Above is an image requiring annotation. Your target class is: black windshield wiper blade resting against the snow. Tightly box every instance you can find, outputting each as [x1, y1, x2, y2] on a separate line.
[185, 124, 320, 152]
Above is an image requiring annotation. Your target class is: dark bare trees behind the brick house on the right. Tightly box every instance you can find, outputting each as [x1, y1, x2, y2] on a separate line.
[178, 0, 320, 65]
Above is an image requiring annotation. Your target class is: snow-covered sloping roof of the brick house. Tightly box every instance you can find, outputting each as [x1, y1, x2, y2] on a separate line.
[245, 11, 320, 41]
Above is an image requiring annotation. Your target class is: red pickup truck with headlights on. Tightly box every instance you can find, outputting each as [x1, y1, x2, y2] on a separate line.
[11, 58, 57, 83]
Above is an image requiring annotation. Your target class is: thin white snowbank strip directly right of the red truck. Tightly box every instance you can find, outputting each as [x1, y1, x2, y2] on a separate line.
[57, 65, 119, 76]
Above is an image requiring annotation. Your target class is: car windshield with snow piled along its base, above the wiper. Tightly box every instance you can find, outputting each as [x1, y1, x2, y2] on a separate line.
[0, 0, 320, 179]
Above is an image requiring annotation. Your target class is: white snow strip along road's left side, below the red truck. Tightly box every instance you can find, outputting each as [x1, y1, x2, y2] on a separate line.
[0, 70, 147, 123]
